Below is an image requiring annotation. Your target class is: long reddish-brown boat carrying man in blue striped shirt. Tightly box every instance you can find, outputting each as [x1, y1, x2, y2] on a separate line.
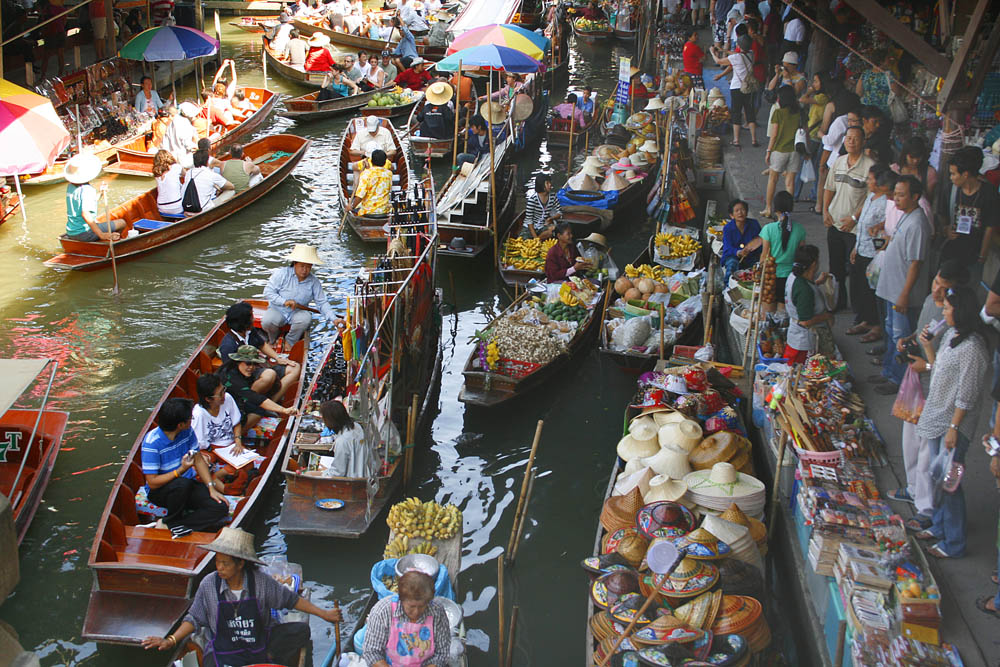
[82, 300, 308, 644]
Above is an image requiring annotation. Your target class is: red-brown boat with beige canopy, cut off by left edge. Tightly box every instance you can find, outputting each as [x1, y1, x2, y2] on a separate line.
[0, 359, 69, 544]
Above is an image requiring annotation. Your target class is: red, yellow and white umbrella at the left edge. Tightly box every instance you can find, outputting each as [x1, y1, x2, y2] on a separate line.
[0, 79, 71, 176]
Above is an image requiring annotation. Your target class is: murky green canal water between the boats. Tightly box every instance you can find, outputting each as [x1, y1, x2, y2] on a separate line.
[0, 23, 651, 665]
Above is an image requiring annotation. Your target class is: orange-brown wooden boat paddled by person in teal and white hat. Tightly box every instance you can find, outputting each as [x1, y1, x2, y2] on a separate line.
[45, 134, 310, 271]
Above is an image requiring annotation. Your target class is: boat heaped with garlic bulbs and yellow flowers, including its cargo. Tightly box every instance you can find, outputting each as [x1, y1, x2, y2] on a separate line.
[458, 276, 608, 407]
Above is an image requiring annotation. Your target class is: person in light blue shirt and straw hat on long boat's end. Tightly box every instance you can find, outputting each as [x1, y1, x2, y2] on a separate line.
[260, 247, 348, 350]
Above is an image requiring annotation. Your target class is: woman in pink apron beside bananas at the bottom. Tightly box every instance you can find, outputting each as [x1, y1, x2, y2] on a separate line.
[362, 570, 451, 667]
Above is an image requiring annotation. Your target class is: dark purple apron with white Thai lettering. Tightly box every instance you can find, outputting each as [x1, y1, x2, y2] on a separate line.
[212, 573, 268, 667]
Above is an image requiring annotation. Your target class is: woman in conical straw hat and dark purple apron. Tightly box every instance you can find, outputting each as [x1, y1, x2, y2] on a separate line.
[142, 526, 344, 667]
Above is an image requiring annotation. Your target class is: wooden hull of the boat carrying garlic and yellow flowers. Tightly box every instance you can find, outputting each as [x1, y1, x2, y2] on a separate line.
[458, 278, 610, 407]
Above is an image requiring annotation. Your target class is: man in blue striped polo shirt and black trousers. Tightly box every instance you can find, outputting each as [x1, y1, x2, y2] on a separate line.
[141, 398, 229, 538]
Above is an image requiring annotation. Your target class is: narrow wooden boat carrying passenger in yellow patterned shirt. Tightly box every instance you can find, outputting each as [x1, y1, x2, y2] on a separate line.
[336, 117, 414, 243]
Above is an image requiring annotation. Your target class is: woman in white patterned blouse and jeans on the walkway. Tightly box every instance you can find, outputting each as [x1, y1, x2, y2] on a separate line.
[911, 287, 991, 558]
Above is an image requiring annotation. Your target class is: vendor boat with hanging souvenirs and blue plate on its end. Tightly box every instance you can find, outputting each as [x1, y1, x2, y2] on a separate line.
[278, 188, 441, 538]
